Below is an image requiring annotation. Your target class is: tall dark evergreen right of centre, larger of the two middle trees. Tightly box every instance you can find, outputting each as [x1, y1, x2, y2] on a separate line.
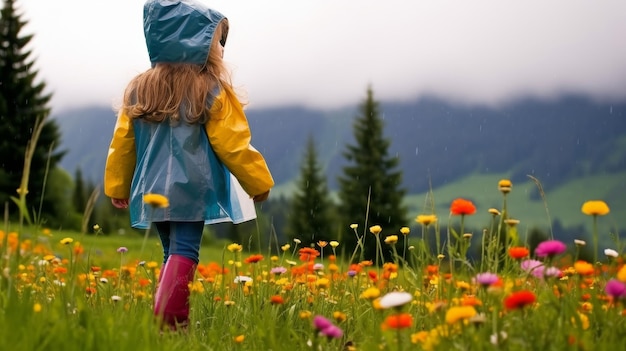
[338, 87, 407, 261]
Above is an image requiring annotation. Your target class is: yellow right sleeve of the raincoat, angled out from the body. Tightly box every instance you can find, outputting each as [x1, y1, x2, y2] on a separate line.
[205, 87, 274, 196]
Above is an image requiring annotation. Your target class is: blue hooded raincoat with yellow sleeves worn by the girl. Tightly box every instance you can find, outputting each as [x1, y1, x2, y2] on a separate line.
[104, 0, 274, 228]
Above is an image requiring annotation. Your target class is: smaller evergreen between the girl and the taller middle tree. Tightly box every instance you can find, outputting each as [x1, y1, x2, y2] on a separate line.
[287, 136, 334, 246]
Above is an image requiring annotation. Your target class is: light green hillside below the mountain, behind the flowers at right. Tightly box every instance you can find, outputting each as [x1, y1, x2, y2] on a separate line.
[407, 172, 626, 235]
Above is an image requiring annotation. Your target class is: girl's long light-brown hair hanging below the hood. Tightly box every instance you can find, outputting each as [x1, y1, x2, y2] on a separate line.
[122, 19, 232, 123]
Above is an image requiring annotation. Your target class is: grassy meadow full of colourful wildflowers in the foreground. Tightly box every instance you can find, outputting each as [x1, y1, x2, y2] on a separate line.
[0, 179, 626, 350]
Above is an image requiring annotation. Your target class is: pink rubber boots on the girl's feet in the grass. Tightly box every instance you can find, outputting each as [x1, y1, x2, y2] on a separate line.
[154, 255, 196, 330]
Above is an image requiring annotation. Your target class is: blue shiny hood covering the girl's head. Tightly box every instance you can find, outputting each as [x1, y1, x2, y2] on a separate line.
[143, 0, 228, 66]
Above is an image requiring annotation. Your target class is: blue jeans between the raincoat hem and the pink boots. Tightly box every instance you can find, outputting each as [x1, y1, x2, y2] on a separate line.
[154, 222, 204, 264]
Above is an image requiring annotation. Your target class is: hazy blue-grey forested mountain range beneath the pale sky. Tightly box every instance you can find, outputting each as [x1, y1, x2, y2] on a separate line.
[54, 96, 626, 193]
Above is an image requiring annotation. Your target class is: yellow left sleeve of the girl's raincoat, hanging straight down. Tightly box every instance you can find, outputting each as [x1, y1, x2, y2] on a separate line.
[104, 110, 137, 199]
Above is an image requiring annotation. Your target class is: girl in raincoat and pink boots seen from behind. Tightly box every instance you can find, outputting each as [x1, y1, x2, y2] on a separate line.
[104, 0, 274, 328]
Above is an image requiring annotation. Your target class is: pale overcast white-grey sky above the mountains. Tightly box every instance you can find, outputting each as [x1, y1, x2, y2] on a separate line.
[16, 0, 626, 113]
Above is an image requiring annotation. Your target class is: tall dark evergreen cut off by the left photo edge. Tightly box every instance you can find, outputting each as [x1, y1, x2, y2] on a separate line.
[0, 0, 63, 217]
